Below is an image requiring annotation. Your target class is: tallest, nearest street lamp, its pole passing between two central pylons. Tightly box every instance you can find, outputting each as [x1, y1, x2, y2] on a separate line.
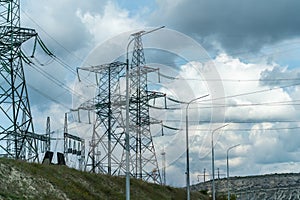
[125, 26, 165, 200]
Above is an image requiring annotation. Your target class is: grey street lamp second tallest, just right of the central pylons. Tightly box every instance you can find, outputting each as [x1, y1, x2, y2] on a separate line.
[185, 94, 209, 200]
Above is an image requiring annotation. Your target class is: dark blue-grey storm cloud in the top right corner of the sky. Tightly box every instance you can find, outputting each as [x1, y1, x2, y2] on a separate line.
[153, 0, 300, 52]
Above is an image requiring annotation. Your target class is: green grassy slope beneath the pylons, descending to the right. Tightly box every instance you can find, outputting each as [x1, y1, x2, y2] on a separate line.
[0, 158, 208, 200]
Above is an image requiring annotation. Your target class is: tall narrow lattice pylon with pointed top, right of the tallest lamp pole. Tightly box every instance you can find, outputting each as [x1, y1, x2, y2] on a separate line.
[123, 31, 162, 184]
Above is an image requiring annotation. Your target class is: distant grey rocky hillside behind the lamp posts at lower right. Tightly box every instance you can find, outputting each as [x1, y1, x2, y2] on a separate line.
[192, 173, 300, 200]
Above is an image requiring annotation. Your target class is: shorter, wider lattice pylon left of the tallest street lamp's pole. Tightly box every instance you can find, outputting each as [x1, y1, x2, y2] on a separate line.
[78, 62, 125, 175]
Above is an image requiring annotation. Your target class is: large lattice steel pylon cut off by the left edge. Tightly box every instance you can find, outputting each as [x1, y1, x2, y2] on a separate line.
[0, 0, 41, 160]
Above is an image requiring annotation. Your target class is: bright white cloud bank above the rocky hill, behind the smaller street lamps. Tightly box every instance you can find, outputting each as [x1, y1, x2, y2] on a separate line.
[158, 54, 299, 186]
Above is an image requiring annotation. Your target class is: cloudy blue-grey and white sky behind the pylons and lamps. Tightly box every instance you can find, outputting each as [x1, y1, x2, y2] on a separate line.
[21, 0, 300, 186]
